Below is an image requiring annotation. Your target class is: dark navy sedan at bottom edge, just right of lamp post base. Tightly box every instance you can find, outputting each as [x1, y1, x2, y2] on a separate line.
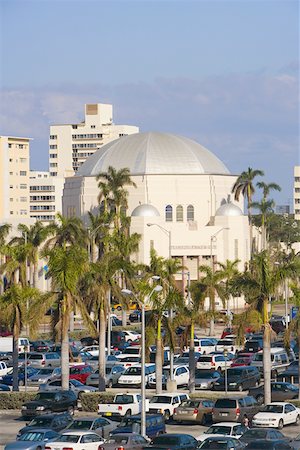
[144, 433, 199, 450]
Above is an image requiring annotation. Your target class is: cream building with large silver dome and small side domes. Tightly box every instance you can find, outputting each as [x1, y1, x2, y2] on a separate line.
[63, 132, 253, 304]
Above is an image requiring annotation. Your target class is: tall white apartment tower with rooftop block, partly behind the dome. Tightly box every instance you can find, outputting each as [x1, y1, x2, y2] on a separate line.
[49, 103, 139, 177]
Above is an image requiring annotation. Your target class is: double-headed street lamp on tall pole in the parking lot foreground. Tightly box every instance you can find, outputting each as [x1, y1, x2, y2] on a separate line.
[121, 284, 163, 437]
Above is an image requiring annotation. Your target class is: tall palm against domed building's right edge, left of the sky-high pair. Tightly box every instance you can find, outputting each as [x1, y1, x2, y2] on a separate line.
[231, 167, 264, 253]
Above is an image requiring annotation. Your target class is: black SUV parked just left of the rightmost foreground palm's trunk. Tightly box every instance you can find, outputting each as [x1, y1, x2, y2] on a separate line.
[213, 366, 260, 391]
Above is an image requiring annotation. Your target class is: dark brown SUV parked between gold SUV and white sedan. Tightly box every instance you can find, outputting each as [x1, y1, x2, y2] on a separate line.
[213, 395, 260, 423]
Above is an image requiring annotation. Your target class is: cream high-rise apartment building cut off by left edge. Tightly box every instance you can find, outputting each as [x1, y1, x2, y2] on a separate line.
[0, 136, 30, 222]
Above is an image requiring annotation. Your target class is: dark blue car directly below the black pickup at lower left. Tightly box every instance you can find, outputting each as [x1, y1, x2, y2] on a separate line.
[17, 413, 73, 436]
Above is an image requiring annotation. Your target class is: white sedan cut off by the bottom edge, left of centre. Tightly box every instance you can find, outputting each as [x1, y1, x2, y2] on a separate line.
[45, 431, 104, 450]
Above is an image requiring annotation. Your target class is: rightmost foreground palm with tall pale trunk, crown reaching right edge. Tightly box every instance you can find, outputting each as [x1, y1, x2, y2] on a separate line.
[234, 250, 299, 403]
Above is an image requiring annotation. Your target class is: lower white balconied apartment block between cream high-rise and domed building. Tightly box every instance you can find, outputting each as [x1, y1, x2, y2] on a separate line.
[29, 170, 64, 222]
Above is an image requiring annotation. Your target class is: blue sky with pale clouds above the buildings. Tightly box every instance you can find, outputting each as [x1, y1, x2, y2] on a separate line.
[0, 0, 300, 204]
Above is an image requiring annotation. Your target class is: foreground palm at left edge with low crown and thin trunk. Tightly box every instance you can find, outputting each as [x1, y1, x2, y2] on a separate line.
[0, 284, 48, 391]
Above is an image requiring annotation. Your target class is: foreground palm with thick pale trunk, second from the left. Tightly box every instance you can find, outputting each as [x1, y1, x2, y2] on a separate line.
[48, 244, 92, 389]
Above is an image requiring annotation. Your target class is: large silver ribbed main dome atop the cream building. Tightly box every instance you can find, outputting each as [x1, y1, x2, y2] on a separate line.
[77, 132, 229, 177]
